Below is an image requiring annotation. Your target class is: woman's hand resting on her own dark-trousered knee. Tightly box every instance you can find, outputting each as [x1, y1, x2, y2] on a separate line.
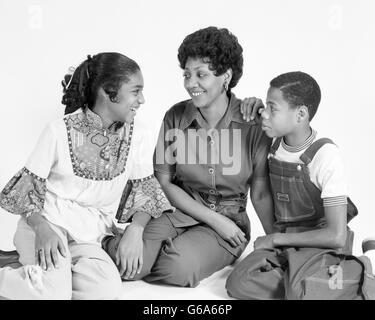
[211, 214, 247, 247]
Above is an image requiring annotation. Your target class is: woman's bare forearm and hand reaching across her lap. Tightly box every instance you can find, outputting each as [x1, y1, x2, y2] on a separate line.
[155, 172, 246, 247]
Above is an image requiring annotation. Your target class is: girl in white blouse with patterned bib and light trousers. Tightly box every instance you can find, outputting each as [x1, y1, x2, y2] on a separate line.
[0, 53, 170, 299]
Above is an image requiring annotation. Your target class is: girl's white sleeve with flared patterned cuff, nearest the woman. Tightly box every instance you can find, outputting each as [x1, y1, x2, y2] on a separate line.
[116, 117, 174, 223]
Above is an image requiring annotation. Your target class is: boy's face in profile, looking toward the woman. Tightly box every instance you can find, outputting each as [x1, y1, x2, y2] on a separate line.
[262, 87, 298, 138]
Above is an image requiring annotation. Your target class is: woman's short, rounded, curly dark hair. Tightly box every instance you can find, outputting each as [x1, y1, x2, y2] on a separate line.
[178, 27, 243, 90]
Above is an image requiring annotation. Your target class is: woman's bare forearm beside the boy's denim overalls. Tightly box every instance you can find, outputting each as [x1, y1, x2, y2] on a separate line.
[250, 178, 275, 234]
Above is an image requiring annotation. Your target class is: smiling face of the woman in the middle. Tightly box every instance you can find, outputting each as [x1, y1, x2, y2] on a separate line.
[183, 58, 225, 108]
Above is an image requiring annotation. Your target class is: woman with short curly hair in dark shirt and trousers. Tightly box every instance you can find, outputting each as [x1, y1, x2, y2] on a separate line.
[106, 27, 272, 287]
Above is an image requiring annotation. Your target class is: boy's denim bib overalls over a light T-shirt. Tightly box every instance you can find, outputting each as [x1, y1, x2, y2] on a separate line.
[226, 138, 375, 299]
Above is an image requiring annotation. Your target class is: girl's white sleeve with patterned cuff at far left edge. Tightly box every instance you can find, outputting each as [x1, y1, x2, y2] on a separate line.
[0, 126, 56, 214]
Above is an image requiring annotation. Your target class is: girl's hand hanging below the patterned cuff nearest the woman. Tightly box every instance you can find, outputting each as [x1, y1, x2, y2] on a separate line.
[116, 223, 143, 279]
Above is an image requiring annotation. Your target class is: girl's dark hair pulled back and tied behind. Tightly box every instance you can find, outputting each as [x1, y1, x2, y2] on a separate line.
[61, 52, 140, 114]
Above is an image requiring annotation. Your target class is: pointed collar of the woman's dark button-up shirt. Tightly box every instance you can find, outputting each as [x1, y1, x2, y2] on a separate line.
[180, 93, 255, 130]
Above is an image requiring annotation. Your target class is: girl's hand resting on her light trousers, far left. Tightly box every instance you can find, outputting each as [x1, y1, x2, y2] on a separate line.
[33, 218, 66, 271]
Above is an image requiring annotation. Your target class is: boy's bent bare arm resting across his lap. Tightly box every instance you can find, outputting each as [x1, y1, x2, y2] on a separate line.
[272, 205, 347, 249]
